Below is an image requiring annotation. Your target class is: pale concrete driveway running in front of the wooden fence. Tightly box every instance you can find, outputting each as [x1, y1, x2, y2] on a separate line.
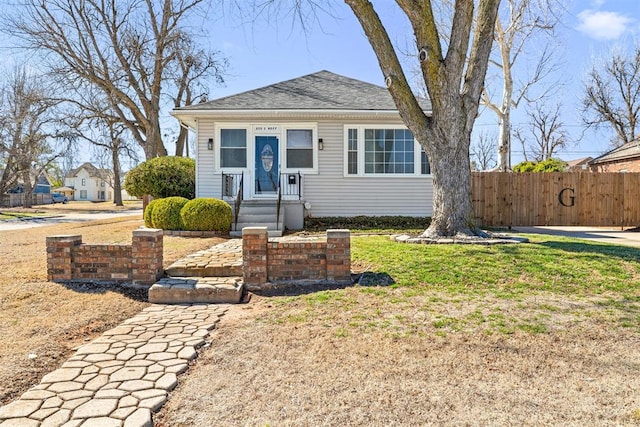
[512, 226, 640, 247]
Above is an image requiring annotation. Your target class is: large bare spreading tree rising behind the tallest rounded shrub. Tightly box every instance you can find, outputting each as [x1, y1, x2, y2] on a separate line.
[7, 0, 225, 158]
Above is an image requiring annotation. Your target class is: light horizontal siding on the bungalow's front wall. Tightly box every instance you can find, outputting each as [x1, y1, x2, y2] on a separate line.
[196, 118, 433, 217]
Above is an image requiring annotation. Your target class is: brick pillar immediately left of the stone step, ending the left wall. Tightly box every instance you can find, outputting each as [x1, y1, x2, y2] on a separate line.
[131, 228, 164, 285]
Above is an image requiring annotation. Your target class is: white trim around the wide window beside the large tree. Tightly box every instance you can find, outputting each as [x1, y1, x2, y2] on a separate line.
[343, 124, 431, 179]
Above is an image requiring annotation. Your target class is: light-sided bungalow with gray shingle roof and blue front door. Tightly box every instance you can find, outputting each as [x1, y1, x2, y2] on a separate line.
[171, 71, 433, 236]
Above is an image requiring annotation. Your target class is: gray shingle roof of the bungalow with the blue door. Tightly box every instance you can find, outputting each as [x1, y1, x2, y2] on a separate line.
[176, 71, 431, 111]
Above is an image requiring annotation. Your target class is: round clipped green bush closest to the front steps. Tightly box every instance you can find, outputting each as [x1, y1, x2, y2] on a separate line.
[180, 198, 231, 232]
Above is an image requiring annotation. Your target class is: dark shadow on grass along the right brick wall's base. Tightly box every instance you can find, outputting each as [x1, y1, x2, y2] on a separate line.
[252, 271, 395, 297]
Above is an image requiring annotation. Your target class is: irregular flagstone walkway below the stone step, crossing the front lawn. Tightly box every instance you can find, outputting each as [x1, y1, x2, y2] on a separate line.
[0, 304, 228, 427]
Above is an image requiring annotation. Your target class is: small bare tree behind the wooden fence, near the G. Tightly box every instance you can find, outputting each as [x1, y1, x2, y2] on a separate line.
[514, 103, 571, 162]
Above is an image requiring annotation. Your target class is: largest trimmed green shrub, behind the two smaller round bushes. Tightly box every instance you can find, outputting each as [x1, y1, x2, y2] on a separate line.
[124, 156, 196, 199]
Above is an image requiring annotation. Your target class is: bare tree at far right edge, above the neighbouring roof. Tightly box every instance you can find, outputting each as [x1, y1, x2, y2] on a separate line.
[582, 46, 640, 147]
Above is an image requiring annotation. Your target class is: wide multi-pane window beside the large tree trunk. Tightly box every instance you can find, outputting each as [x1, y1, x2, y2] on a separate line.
[345, 126, 431, 176]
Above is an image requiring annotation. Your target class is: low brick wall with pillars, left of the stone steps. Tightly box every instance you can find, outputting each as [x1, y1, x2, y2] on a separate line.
[47, 229, 164, 285]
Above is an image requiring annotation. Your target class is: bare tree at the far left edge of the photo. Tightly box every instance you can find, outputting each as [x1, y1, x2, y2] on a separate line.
[0, 67, 74, 207]
